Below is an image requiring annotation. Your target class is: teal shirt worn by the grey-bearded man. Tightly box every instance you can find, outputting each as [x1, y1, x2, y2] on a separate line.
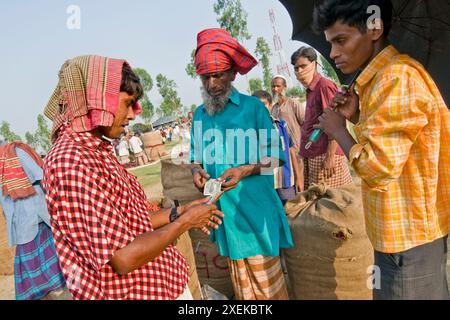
[191, 89, 293, 260]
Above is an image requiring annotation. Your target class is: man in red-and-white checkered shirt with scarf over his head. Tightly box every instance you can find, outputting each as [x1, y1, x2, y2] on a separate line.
[44, 56, 223, 299]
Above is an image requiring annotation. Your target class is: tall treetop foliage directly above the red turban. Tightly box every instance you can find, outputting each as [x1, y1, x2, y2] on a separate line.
[214, 0, 251, 41]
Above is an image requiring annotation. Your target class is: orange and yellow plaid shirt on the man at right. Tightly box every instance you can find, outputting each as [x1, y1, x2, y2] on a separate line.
[350, 46, 450, 253]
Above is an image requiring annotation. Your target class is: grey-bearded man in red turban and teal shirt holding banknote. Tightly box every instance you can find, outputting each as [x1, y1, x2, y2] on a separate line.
[191, 29, 292, 300]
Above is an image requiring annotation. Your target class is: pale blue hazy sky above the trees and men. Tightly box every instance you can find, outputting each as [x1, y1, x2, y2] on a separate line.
[0, 0, 302, 137]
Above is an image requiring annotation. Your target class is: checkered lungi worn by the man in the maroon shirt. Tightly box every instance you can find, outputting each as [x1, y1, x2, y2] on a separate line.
[304, 154, 353, 190]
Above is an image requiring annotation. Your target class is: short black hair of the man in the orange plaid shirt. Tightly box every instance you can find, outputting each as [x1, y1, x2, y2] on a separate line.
[313, 0, 393, 37]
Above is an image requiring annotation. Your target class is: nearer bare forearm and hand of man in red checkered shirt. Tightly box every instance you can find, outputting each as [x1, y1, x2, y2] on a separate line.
[109, 199, 224, 275]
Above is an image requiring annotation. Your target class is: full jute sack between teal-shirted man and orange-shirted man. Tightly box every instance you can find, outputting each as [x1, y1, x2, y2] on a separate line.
[283, 184, 373, 300]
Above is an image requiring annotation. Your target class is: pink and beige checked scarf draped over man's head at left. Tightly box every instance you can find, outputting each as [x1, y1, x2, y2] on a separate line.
[44, 55, 142, 141]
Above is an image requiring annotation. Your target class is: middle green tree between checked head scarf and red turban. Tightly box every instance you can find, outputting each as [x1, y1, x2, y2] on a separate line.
[156, 74, 182, 116]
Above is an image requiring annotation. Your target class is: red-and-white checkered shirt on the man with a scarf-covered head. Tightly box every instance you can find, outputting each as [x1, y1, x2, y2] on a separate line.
[44, 128, 188, 300]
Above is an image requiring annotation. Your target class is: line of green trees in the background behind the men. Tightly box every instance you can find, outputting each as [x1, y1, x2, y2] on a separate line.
[0, 0, 339, 154]
